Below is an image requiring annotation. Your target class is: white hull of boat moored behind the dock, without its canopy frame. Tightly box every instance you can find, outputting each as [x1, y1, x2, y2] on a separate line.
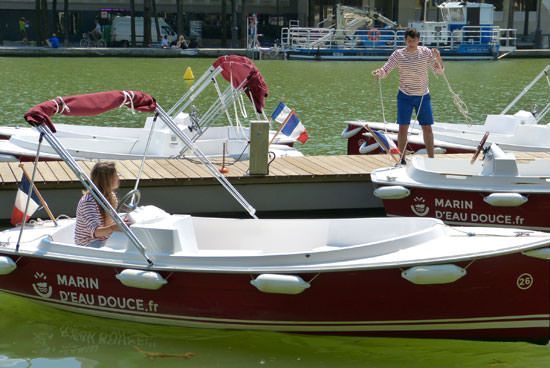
[0, 113, 303, 161]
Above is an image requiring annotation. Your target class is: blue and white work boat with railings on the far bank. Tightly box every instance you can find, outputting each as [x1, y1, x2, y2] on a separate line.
[281, 1, 516, 60]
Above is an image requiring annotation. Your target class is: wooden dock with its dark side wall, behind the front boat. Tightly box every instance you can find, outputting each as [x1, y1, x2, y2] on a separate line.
[0, 155, 394, 221]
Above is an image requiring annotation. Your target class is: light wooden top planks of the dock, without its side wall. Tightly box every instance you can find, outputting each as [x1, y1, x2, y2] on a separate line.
[0, 152, 550, 190]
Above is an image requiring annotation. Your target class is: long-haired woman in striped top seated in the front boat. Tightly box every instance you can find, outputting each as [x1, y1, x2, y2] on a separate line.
[74, 162, 125, 248]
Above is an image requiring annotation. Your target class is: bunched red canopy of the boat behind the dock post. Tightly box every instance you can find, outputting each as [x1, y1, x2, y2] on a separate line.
[213, 55, 269, 112]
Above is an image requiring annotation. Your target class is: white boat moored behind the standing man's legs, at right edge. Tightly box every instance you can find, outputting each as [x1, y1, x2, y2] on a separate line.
[342, 65, 550, 154]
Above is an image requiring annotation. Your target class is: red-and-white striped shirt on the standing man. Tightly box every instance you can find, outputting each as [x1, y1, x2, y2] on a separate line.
[382, 46, 444, 96]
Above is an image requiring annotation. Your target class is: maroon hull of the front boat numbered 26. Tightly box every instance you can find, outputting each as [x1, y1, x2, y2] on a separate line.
[0, 252, 550, 343]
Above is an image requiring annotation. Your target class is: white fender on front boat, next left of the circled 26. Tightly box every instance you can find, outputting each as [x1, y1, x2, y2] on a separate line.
[401, 264, 466, 285]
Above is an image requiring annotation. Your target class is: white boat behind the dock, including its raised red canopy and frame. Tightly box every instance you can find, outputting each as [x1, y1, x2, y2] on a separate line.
[0, 55, 303, 161]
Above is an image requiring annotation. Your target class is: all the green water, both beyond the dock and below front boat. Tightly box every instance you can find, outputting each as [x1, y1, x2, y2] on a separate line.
[0, 58, 550, 368]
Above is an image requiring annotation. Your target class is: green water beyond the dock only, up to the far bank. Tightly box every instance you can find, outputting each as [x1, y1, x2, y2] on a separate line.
[0, 58, 550, 155]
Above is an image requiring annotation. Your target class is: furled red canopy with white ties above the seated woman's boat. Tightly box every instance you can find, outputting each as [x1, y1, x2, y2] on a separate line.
[25, 91, 157, 133]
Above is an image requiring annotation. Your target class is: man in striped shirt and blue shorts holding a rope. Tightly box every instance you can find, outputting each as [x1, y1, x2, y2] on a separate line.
[372, 28, 444, 163]
